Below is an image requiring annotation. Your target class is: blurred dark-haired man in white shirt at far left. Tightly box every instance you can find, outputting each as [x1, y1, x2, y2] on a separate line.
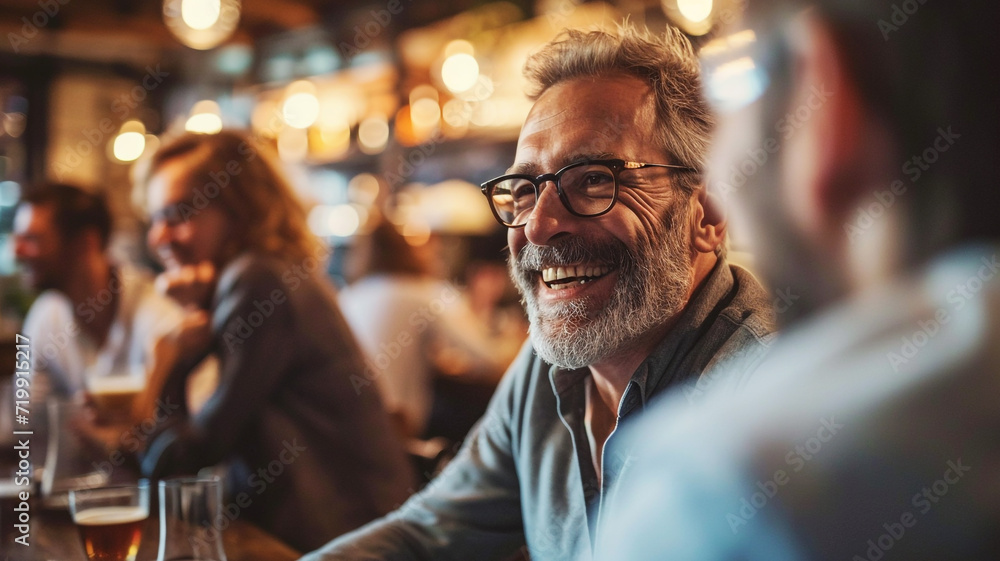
[14, 184, 181, 413]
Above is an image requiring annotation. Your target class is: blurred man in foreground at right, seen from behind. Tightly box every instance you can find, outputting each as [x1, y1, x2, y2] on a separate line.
[599, 0, 1000, 561]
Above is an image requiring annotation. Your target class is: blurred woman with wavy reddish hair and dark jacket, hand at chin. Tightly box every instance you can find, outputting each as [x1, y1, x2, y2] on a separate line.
[134, 131, 412, 549]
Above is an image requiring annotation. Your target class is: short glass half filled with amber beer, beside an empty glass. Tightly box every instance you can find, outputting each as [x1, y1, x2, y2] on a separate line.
[69, 481, 149, 561]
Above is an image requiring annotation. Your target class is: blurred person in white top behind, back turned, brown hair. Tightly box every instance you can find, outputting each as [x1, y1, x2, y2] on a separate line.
[339, 220, 521, 437]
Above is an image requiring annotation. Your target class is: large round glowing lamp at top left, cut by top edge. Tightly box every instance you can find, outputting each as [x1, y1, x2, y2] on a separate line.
[163, 0, 240, 50]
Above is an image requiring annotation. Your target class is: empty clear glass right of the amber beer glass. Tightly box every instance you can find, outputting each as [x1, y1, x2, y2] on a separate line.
[157, 477, 229, 561]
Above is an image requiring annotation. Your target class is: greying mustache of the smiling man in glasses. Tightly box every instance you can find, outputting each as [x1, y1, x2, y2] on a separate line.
[511, 236, 631, 272]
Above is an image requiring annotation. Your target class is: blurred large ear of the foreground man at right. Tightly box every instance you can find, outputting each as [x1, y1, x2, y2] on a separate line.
[779, 13, 884, 243]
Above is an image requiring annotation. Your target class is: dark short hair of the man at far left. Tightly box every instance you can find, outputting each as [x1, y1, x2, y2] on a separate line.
[19, 183, 111, 249]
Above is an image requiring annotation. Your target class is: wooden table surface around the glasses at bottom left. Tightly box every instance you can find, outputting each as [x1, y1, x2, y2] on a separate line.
[0, 509, 301, 561]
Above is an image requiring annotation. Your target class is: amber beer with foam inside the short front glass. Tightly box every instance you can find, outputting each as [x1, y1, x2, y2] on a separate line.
[73, 506, 149, 561]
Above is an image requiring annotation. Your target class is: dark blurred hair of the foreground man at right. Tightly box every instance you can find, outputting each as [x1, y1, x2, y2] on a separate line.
[748, 0, 1000, 265]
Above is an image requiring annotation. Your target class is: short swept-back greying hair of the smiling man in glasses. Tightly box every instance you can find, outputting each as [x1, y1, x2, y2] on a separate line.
[524, 20, 713, 193]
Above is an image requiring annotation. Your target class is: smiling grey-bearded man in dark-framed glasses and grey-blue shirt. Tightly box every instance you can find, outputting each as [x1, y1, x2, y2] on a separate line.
[306, 21, 772, 561]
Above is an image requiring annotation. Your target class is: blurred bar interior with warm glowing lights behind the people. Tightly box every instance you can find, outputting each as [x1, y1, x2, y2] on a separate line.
[0, 0, 738, 559]
